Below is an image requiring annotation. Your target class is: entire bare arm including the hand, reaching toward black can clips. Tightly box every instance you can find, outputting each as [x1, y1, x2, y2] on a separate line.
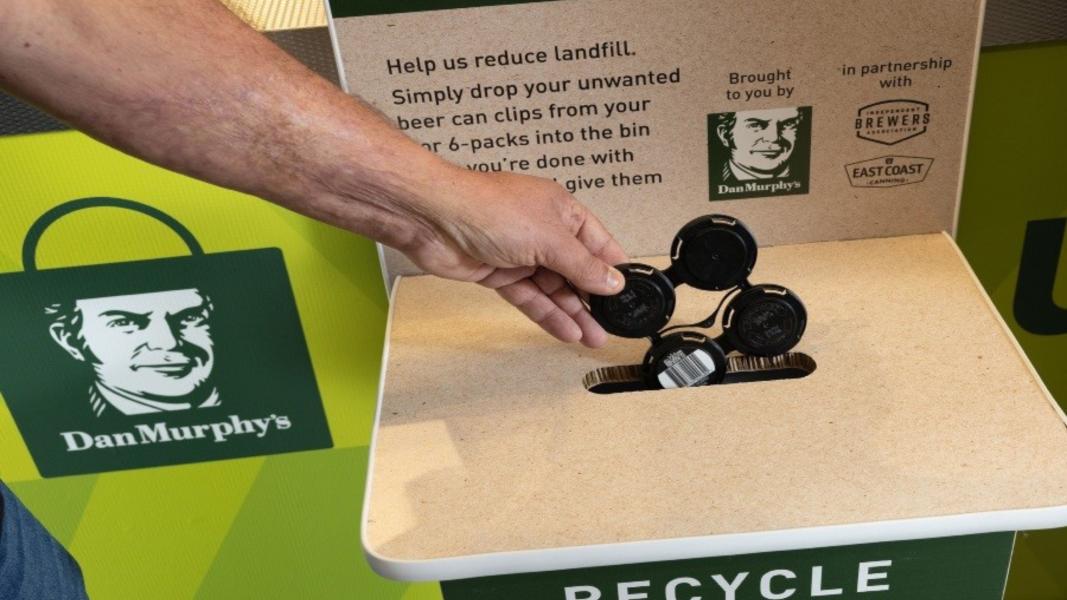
[0, 0, 625, 346]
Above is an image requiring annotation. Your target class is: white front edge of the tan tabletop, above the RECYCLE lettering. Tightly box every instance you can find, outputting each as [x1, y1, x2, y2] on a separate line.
[365, 506, 1067, 581]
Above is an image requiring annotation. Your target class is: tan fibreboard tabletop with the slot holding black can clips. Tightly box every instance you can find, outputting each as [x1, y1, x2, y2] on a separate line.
[363, 234, 1067, 579]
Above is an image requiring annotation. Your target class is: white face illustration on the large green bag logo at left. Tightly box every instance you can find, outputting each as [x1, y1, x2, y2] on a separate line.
[53, 289, 214, 401]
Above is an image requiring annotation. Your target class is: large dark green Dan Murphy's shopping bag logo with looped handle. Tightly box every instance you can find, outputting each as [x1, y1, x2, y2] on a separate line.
[0, 198, 332, 477]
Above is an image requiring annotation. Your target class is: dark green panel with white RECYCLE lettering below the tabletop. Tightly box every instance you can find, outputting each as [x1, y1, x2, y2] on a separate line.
[442, 533, 1014, 600]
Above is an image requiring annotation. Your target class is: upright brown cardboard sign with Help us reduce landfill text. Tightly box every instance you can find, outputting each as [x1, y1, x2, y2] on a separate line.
[331, 0, 982, 279]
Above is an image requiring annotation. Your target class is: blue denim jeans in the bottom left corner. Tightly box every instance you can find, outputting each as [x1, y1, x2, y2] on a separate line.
[0, 481, 87, 600]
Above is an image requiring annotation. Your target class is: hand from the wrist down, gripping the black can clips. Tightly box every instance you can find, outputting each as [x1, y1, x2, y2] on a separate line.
[399, 168, 626, 348]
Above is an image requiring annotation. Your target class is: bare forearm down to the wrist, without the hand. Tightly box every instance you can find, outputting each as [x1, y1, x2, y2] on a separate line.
[0, 0, 460, 248]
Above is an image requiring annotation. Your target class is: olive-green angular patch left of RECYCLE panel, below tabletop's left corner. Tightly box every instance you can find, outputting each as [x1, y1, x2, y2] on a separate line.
[197, 447, 408, 600]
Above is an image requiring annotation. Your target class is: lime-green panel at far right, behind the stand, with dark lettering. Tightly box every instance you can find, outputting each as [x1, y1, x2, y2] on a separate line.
[957, 38, 1067, 600]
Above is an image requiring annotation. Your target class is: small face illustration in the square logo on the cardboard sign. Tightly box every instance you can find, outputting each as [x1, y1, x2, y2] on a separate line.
[720, 108, 800, 174]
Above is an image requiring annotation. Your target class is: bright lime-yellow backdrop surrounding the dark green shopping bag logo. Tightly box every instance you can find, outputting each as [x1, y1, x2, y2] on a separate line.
[0, 132, 386, 481]
